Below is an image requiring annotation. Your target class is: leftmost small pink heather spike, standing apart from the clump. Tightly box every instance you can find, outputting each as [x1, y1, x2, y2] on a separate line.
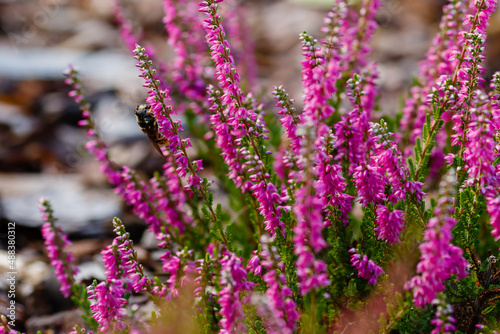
[39, 198, 78, 297]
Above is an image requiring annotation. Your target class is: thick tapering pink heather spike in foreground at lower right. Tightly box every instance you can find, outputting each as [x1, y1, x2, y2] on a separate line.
[405, 169, 468, 307]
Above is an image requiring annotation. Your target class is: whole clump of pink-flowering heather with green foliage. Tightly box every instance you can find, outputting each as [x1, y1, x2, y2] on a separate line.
[1, 0, 500, 333]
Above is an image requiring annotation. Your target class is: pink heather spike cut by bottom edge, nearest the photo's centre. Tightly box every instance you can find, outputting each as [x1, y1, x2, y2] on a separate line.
[247, 235, 300, 333]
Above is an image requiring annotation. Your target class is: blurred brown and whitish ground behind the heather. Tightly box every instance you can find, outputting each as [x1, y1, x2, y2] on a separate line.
[0, 0, 500, 330]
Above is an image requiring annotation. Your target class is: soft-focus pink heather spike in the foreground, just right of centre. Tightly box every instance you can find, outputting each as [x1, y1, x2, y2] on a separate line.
[293, 124, 352, 295]
